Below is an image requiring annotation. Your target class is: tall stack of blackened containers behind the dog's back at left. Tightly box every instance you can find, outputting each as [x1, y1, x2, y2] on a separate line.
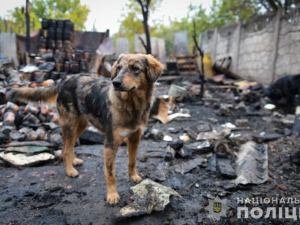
[21, 19, 91, 87]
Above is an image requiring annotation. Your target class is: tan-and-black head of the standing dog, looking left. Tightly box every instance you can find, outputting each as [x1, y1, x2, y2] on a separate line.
[111, 54, 164, 91]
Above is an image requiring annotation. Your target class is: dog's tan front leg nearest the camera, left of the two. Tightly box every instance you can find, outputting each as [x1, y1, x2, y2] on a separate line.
[104, 147, 120, 204]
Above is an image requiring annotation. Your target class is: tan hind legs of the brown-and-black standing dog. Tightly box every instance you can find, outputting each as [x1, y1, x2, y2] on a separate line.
[59, 116, 87, 177]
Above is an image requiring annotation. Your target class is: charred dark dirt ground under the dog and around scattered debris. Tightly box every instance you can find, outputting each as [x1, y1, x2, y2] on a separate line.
[0, 81, 300, 225]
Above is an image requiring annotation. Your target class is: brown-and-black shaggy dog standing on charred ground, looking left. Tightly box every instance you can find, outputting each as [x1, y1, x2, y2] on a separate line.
[7, 54, 163, 204]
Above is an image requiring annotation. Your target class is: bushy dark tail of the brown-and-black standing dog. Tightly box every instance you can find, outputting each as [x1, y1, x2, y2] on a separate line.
[6, 84, 57, 106]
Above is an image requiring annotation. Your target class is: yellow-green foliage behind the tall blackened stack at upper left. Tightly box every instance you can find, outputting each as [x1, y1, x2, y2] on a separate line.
[0, 0, 90, 34]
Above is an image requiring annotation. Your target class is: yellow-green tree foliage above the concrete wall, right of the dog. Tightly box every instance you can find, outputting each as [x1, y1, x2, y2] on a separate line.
[115, 0, 300, 57]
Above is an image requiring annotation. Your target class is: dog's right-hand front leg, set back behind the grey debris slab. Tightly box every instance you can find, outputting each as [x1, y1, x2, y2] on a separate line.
[128, 129, 143, 183]
